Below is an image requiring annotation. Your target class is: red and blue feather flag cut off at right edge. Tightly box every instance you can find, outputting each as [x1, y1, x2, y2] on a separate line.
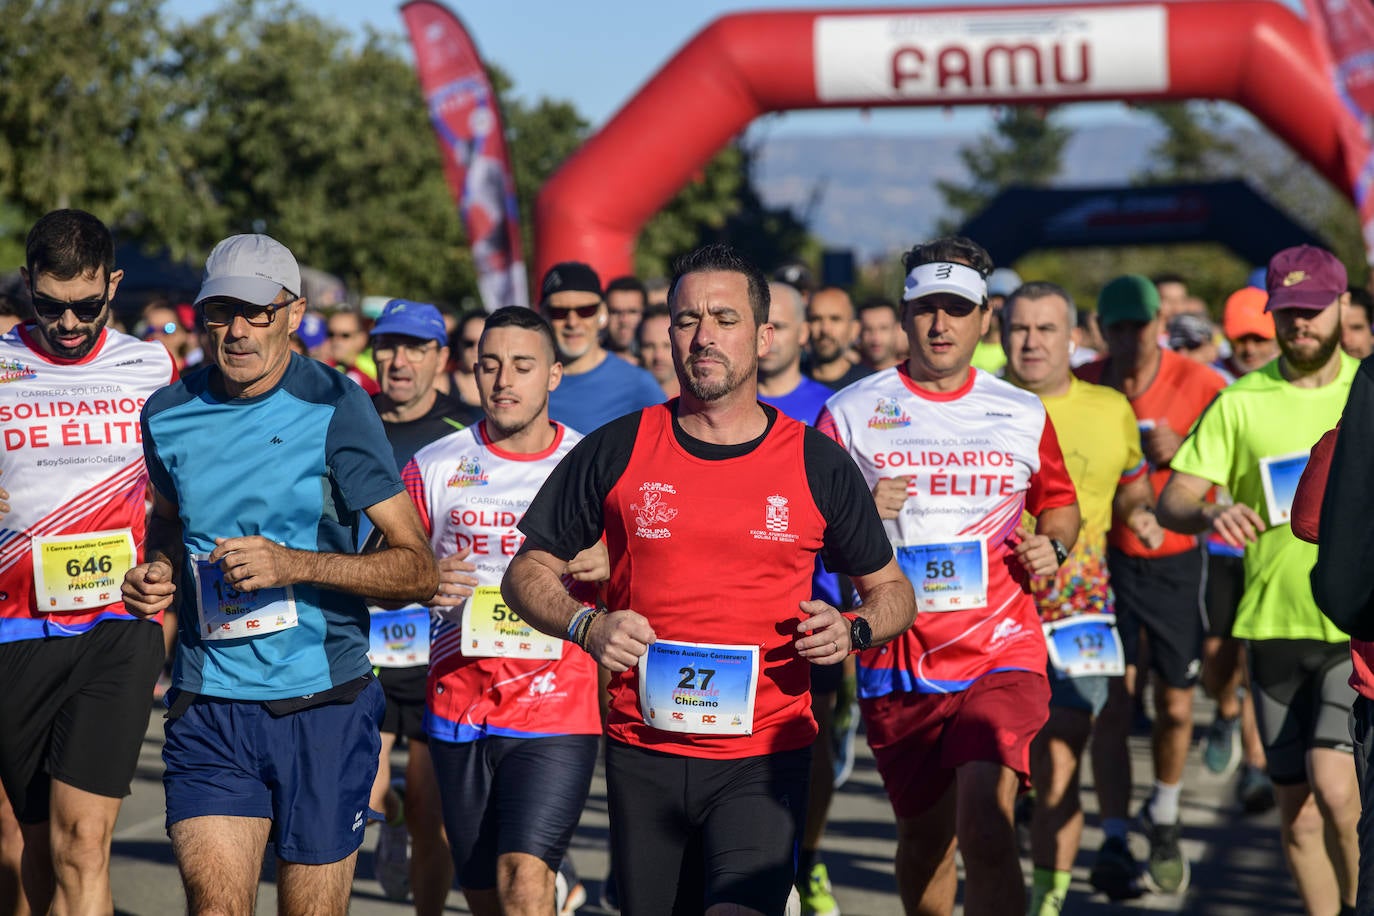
[1304, 0, 1374, 264]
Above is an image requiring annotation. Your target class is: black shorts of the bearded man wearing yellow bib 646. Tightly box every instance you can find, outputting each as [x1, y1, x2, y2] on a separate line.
[0, 621, 165, 824]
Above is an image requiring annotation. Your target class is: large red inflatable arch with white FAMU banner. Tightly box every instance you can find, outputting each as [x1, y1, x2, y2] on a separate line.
[536, 0, 1353, 276]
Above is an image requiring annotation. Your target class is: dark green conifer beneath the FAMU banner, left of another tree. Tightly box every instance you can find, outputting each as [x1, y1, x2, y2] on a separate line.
[936, 106, 1072, 232]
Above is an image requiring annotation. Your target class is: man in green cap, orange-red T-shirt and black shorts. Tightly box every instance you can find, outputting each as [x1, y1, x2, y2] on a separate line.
[1077, 275, 1226, 898]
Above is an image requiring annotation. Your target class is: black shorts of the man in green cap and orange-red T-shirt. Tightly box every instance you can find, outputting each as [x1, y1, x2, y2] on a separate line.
[1107, 548, 1202, 687]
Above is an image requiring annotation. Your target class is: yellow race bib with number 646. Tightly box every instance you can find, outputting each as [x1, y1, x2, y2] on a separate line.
[33, 527, 137, 612]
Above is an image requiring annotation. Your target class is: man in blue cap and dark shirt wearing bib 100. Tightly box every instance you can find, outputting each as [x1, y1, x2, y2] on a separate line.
[368, 299, 475, 916]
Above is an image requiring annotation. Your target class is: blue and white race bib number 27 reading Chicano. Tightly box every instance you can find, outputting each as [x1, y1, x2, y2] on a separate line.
[639, 640, 758, 735]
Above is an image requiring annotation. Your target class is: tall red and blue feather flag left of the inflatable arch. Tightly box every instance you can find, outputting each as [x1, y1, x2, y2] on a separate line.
[401, 0, 529, 312]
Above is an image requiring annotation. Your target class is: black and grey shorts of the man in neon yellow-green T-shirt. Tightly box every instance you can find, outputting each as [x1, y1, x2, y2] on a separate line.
[1248, 640, 1355, 786]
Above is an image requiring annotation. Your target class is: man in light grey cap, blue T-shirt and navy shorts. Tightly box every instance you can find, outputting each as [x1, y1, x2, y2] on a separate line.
[124, 235, 438, 915]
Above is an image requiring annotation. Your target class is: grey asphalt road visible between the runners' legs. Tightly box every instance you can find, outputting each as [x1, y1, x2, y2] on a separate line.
[111, 702, 1303, 916]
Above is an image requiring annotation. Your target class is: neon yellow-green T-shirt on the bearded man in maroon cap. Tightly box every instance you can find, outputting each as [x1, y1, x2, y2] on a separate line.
[1171, 354, 1359, 643]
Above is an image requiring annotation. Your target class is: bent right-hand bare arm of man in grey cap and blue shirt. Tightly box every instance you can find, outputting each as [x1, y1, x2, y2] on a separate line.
[210, 493, 438, 603]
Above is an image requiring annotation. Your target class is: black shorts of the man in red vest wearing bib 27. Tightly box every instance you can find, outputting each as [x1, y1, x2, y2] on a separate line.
[606, 740, 811, 916]
